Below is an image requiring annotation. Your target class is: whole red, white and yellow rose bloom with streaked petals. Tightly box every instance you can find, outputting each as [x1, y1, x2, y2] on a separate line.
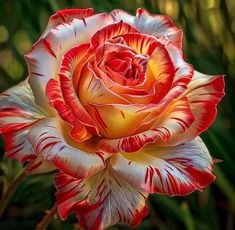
[0, 9, 224, 229]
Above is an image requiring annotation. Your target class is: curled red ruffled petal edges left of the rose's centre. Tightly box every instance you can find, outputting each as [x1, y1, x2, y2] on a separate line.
[45, 44, 98, 138]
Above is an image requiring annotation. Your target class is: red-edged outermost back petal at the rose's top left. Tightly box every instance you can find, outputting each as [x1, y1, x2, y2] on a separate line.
[41, 8, 93, 38]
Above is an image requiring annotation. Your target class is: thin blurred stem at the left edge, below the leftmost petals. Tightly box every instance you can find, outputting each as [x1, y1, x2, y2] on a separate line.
[0, 170, 26, 219]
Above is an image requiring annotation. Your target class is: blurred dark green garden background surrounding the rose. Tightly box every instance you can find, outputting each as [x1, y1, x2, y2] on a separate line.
[0, 0, 235, 230]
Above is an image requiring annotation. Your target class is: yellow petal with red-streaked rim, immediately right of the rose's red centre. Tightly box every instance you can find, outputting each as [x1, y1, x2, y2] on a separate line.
[123, 34, 176, 99]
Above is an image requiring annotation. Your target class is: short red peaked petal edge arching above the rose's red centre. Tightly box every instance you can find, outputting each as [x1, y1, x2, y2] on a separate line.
[91, 21, 139, 48]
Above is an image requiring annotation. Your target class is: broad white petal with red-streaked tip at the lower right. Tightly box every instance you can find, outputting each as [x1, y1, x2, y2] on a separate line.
[110, 137, 215, 196]
